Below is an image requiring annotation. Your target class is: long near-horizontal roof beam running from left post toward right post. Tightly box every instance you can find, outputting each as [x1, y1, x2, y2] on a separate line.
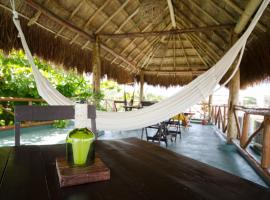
[98, 24, 234, 39]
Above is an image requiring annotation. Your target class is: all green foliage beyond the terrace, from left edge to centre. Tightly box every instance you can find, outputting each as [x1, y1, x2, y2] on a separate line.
[0, 50, 165, 127]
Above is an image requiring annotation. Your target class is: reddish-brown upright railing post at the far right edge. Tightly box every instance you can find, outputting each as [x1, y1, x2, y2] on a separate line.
[261, 116, 270, 169]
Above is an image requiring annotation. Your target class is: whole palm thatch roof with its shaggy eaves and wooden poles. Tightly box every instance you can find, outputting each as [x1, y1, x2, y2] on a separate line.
[0, 0, 270, 86]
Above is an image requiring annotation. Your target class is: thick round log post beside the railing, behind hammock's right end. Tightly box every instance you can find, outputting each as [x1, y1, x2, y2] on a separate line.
[227, 0, 261, 143]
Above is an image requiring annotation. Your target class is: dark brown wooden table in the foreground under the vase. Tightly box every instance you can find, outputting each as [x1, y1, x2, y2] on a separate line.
[0, 138, 270, 200]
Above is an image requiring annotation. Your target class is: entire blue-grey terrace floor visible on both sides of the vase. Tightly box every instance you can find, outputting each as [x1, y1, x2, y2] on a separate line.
[0, 123, 269, 187]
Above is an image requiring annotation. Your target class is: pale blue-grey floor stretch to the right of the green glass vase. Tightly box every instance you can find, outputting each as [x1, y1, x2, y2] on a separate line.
[100, 124, 268, 187]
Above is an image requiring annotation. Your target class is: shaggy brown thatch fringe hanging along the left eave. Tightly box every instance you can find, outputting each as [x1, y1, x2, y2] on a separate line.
[0, 10, 133, 83]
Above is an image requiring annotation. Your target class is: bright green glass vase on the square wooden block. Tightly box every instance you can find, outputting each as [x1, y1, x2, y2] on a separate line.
[66, 128, 95, 166]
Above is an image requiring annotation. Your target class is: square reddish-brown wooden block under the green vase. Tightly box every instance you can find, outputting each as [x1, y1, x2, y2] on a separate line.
[56, 155, 110, 187]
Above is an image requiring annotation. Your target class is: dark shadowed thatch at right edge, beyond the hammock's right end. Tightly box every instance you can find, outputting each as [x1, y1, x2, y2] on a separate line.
[240, 33, 270, 88]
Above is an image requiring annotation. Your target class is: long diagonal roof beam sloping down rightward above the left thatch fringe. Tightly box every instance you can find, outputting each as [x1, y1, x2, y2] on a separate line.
[25, 0, 136, 72]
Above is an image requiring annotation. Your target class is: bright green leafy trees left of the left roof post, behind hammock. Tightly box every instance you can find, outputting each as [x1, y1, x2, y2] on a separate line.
[0, 51, 95, 125]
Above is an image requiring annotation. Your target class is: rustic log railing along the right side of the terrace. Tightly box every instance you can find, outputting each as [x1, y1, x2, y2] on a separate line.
[210, 105, 270, 183]
